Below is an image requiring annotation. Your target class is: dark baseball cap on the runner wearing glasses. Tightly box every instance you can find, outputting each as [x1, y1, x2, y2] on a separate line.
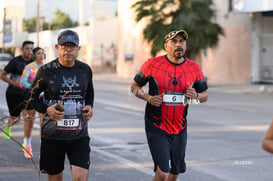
[58, 30, 79, 46]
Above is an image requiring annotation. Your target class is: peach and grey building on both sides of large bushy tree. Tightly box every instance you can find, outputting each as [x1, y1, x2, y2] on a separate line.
[117, 0, 273, 85]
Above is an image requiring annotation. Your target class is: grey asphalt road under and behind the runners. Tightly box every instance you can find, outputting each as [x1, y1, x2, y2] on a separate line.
[0, 75, 273, 181]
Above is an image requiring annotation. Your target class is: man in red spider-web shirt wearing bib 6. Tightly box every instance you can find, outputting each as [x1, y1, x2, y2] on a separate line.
[131, 30, 208, 181]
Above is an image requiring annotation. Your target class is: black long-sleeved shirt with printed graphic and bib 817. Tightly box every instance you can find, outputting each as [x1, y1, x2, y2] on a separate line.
[31, 60, 94, 139]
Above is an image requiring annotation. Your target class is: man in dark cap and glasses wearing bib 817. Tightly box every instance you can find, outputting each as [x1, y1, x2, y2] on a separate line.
[29, 30, 94, 180]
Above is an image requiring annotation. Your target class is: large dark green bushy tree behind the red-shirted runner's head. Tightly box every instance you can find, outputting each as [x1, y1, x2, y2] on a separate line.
[132, 0, 224, 58]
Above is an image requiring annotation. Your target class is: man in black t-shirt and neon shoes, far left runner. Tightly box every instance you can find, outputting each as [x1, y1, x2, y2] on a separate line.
[0, 40, 34, 146]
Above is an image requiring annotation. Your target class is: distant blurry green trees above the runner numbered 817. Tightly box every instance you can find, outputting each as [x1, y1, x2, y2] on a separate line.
[23, 9, 78, 32]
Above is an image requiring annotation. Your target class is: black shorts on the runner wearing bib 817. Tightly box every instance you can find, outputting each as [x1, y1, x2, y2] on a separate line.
[40, 137, 91, 175]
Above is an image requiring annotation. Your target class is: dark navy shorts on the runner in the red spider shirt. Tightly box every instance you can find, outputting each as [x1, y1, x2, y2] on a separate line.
[146, 122, 187, 175]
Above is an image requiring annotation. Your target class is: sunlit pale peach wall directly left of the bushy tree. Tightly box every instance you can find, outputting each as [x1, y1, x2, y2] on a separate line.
[117, 0, 153, 77]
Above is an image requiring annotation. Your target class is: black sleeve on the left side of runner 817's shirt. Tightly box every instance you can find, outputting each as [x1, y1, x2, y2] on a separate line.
[29, 68, 48, 113]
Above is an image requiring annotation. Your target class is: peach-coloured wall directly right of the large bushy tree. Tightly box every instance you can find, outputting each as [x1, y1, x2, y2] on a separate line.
[201, 26, 251, 84]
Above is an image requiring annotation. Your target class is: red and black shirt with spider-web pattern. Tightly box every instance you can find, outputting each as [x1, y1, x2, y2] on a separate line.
[134, 55, 208, 134]
